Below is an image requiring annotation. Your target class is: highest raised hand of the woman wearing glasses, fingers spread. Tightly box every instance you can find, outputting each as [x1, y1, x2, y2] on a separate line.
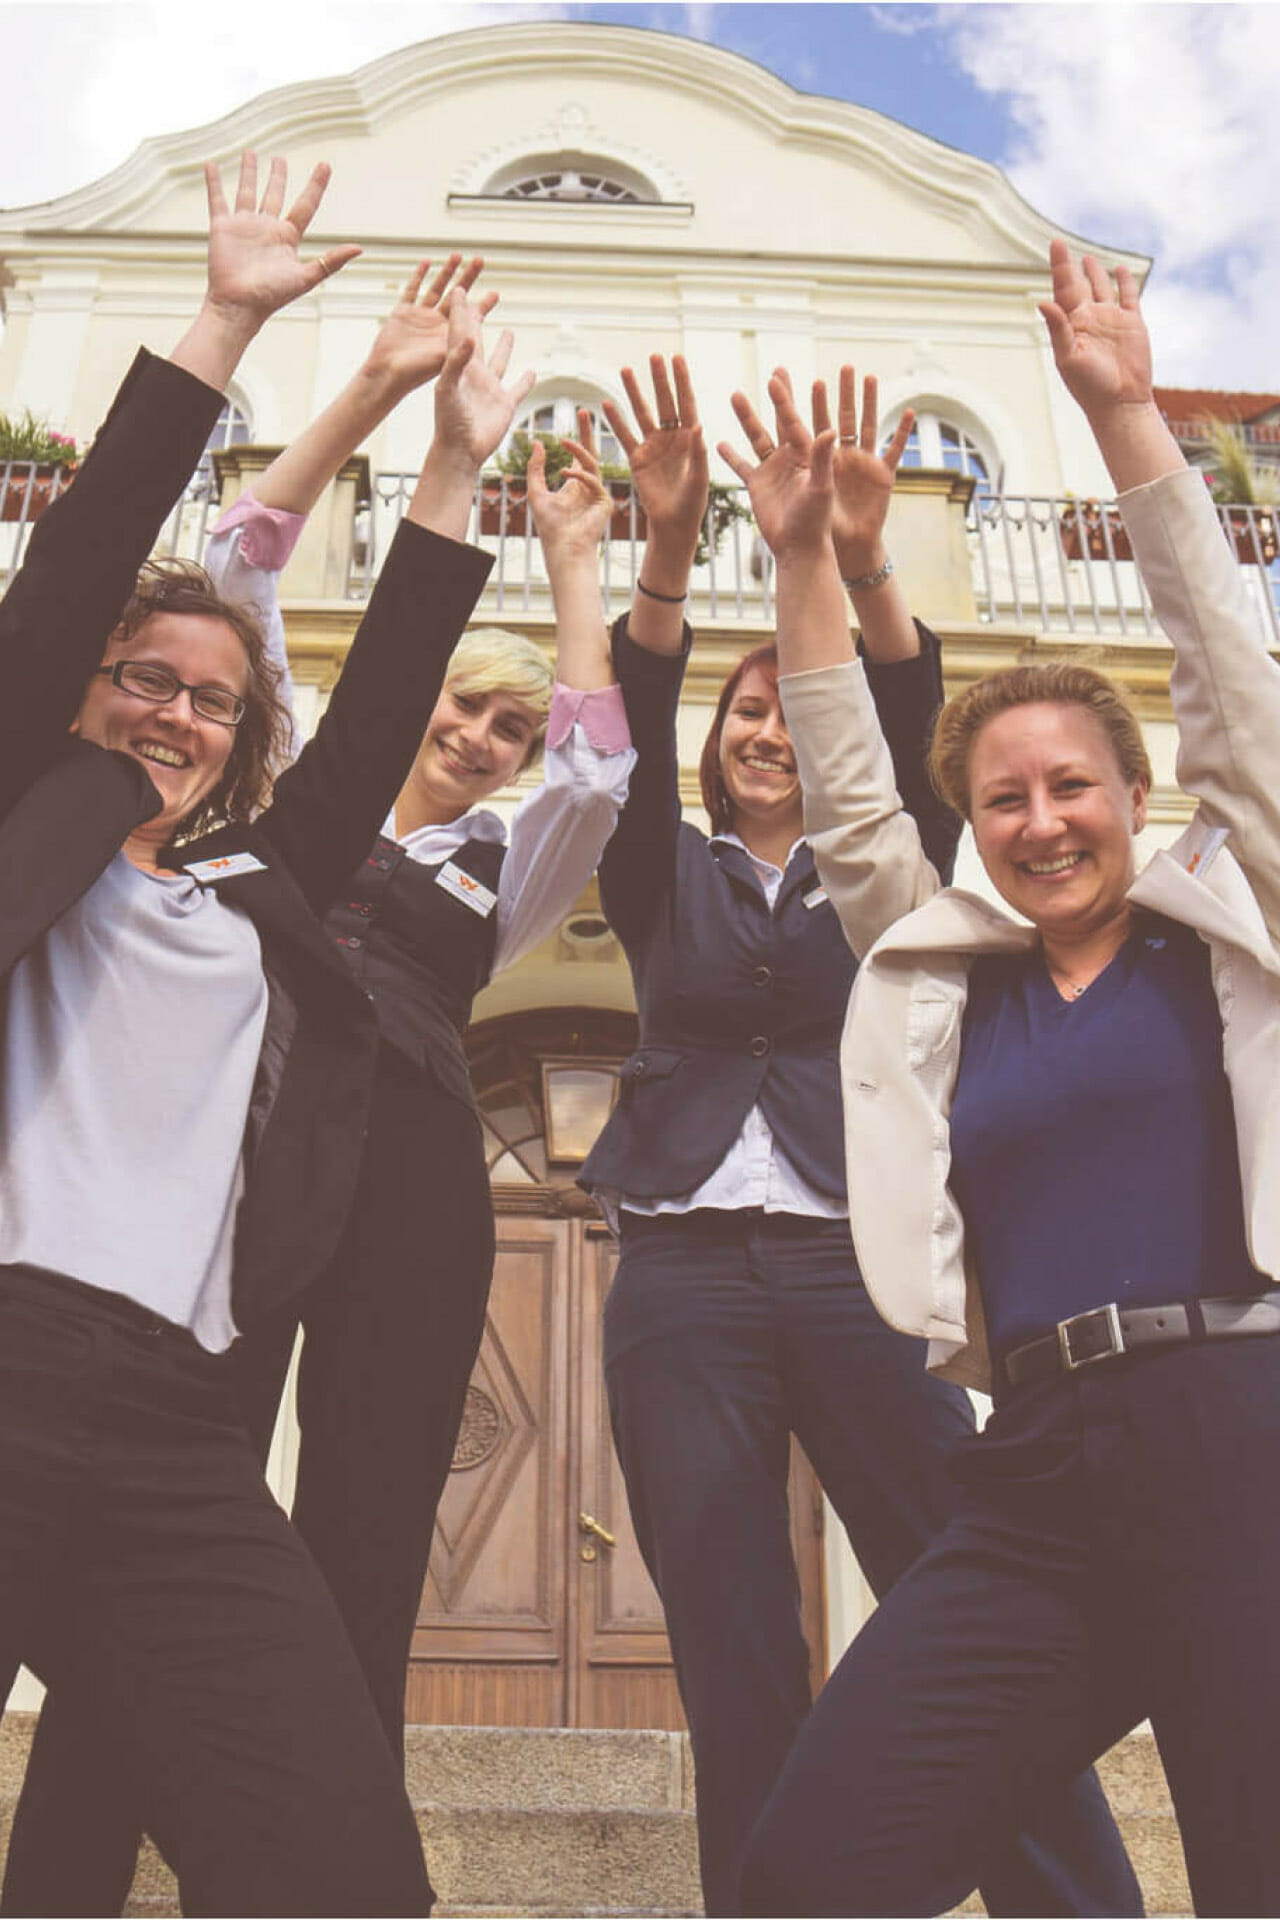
[205, 152, 361, 330]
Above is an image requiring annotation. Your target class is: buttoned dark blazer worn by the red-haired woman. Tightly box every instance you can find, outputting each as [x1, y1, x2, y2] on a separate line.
[581, 620, 961, 1202]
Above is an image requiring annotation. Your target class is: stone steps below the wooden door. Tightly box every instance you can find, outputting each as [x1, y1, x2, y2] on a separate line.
[0, 1713, 1192, 1920]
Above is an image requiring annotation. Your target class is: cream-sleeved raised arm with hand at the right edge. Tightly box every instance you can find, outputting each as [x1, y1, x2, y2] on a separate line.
[1040, 240, 1280, 939]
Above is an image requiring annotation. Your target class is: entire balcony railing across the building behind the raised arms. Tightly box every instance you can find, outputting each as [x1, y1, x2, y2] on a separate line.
[0, 461, 1280, 649]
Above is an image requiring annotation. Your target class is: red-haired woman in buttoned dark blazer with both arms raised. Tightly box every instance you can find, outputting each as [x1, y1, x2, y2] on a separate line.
[583, 357, 1140, 1914]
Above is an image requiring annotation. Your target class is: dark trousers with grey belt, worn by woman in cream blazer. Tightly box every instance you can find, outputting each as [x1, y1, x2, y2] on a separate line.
[745, 1336, 1280, 1914]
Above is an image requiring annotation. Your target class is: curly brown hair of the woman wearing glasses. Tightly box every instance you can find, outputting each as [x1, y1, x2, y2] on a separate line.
[107, 561, 294, 839]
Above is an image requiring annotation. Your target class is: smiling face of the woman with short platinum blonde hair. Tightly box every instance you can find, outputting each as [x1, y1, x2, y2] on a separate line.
[403, 684, 543, 824]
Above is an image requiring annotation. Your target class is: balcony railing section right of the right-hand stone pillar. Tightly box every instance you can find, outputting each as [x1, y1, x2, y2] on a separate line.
[965, 493, 1280, 647]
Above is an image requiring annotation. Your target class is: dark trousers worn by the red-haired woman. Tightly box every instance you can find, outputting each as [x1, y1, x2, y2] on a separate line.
[604, 1212, 1142, 1914]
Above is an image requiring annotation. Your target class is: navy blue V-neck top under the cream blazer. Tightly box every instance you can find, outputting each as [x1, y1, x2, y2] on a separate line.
[952, 914, 1267, 1356]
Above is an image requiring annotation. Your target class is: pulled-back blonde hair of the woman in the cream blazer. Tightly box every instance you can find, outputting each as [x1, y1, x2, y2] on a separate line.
[929, 660, 1151, 820]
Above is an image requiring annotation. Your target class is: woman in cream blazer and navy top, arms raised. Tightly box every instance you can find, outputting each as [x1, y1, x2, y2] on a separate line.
[721, 244, 1280, 1914]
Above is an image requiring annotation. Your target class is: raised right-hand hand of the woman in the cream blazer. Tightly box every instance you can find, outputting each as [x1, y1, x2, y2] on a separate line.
[1040, 240, 1151, 417]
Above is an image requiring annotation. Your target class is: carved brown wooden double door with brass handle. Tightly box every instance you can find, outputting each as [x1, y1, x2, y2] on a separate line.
[405, 1194, 825, 1728]
